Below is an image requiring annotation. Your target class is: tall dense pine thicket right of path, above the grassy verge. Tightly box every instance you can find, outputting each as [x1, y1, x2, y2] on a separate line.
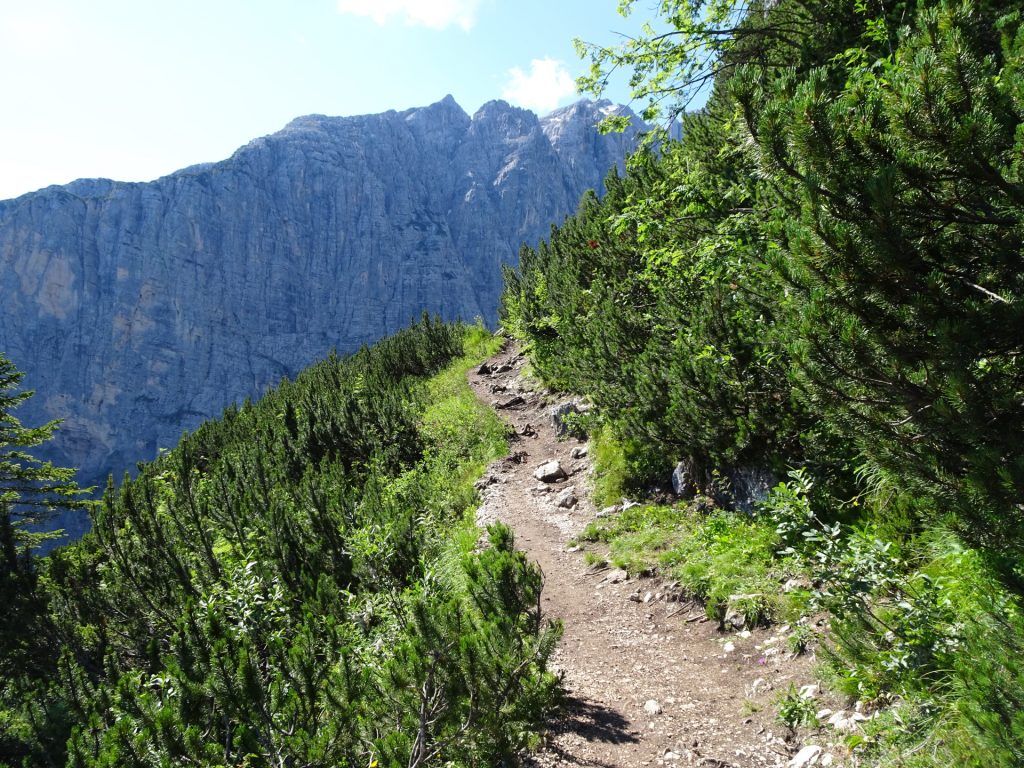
[552, 0, 1024, 536]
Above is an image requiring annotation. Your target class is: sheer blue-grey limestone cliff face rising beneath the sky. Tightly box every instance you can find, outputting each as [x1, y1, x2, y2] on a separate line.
[0, 97, 635, 536]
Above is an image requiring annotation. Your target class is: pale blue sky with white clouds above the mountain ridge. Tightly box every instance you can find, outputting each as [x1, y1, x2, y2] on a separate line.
[0, 0, 654, 199]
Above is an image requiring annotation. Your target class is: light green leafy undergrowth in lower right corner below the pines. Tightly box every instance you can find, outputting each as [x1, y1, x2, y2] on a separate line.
[765, 472, 1024, 766]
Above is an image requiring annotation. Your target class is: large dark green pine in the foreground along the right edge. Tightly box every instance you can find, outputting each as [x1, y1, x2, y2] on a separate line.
[732, 3, 1024, 548]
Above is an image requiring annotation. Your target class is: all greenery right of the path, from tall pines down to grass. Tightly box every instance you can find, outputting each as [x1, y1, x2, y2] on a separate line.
[504, 0, 1024, 766]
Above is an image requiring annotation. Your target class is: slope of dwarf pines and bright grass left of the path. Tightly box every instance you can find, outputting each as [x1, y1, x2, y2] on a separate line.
[0, 318, 559, 768]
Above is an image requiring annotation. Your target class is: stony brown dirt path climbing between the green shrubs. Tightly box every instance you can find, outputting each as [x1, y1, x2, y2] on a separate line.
[469, 344, 810, 768]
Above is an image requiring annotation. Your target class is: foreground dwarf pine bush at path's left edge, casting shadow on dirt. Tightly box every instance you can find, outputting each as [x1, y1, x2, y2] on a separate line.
[364, 525, 560, 765]
